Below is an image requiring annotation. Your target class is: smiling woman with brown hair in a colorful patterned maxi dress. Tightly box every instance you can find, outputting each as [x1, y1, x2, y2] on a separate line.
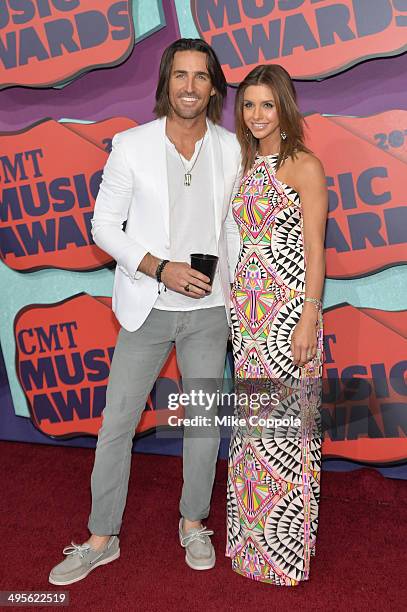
[226, 65, 327, 586]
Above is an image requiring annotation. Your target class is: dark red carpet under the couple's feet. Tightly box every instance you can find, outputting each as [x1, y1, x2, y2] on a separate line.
[0, 442, 407, 612]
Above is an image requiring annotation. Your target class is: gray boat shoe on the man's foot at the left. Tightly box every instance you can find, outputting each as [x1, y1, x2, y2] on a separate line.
[48, 536, 120, 585]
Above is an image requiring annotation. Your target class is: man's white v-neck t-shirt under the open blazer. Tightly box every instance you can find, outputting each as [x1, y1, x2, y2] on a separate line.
[154, 131, 225, 310]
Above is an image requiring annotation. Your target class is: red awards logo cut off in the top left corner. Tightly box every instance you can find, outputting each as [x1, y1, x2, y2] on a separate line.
[0, 0, 134, 88]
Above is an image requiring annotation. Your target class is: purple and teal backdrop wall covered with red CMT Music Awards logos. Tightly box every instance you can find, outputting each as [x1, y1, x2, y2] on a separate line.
[0, 0, 407, 477]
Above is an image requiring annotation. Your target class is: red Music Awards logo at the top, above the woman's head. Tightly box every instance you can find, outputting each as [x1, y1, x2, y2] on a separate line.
[191, 0, 407, 83]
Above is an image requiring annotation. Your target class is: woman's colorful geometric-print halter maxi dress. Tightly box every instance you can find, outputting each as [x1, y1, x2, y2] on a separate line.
[226, 155, 322, 586]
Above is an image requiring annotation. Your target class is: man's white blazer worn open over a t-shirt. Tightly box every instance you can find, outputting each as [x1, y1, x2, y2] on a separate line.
[92, 118, 240, 331]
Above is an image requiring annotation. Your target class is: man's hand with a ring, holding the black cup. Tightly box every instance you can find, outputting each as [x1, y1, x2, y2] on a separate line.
[161, 261, 212, 299]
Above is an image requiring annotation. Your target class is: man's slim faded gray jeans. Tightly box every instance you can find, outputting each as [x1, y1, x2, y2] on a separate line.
[88, 306, 228, 535]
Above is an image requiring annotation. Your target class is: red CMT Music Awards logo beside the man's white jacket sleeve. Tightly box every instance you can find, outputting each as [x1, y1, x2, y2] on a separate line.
[0, 117, 134, 272]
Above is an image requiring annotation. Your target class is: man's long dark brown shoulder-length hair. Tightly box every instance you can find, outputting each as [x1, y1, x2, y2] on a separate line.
[154, 38, 227, 123]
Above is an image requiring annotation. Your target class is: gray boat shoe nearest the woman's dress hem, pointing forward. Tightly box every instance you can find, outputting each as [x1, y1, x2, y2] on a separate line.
[179, 518, 216, 570]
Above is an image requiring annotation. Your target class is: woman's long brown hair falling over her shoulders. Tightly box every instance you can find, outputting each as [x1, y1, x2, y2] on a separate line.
[235, 64, 310, 174]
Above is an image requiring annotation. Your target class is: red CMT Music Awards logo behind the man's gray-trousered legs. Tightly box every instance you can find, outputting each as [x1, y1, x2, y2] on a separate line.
[14, 294, 181, 437]
